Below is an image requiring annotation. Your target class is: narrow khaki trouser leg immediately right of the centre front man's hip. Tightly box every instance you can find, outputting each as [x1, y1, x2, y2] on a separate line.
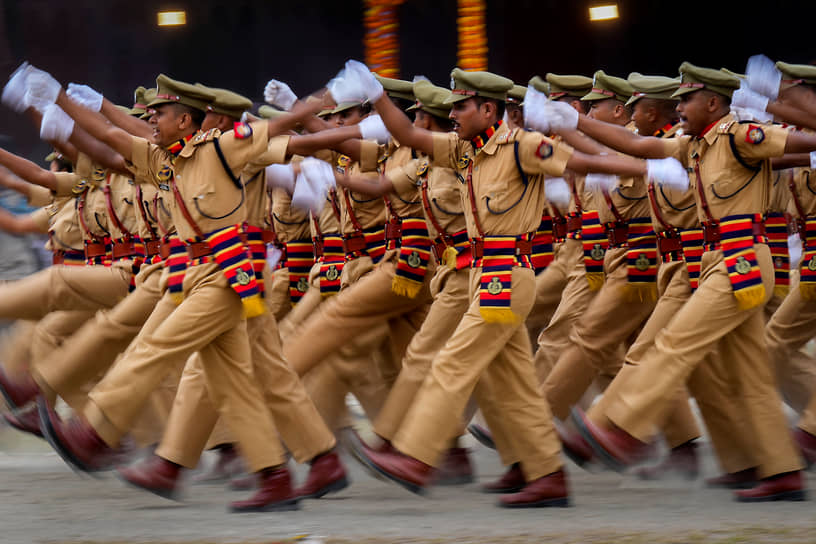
[534, 239, 598, 383]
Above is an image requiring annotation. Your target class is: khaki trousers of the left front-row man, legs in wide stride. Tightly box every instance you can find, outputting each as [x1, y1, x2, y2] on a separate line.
[84, 263, 285, 471]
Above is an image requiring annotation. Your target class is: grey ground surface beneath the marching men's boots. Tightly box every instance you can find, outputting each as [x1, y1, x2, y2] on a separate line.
[0, 428, 816, 544]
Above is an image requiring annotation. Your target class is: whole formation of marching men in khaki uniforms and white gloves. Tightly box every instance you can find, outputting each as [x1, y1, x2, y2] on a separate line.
[0, 53, 816, 511]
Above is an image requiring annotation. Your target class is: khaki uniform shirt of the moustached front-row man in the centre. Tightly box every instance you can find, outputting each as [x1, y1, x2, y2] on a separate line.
[432, 124, 572, 238]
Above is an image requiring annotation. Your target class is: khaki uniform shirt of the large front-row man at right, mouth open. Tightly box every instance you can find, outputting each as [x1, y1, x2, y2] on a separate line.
[663, 114, 788, 221]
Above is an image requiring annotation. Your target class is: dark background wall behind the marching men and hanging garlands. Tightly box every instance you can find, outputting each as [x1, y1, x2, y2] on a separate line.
[0, 0, 816, 158]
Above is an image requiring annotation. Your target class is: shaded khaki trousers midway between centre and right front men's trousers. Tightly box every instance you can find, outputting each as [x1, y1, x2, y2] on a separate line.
[541, 248, 655, 420]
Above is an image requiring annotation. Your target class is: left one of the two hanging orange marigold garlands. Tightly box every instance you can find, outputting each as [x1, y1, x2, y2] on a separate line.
[363, 0, 404, 78]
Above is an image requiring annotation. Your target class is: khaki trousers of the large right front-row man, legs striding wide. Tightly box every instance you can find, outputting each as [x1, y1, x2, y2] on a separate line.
[606, 244, 802, 477]
